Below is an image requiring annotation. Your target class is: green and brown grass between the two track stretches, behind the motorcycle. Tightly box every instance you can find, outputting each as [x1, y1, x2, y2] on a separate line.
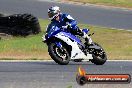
[0, 19, 132, 60]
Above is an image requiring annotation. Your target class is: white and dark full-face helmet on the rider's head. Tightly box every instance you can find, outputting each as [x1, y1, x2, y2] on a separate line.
[48, 6, 60, 20]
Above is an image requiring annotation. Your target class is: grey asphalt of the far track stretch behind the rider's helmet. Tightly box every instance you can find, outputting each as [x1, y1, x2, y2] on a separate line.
[0, 0, 132, 30]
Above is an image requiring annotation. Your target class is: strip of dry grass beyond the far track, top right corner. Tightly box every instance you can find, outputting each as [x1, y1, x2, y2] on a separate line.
[64, 0, 132, 8]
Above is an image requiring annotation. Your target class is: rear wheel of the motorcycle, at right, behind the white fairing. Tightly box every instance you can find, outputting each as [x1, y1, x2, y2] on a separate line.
[91, 43, 107, 65]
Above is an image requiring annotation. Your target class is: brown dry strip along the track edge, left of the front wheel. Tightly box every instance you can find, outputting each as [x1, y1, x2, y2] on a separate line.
[0, 52, 51, 60]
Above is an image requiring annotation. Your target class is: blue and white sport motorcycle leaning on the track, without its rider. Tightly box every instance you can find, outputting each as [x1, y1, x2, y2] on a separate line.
[42, 25, 107, 65]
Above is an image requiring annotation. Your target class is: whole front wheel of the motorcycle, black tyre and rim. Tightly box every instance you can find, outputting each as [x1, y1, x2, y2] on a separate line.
[48, 43, 70, 65]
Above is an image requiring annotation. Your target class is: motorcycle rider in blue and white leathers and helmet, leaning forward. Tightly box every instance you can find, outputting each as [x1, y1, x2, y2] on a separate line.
[48, 6, 88, 42]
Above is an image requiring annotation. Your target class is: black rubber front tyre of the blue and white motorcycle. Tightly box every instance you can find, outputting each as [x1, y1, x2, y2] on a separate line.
[48, 43, 70, 65]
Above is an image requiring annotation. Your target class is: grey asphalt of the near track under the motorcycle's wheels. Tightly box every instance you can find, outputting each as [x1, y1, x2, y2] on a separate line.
[0, 61, 132, 88]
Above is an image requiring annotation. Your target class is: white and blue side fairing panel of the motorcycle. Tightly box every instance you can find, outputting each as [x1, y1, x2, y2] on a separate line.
[55, 32, 93, 60]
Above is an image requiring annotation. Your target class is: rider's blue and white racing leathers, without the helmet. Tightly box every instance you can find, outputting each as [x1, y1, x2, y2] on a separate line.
[47, 13, 88, 42]
